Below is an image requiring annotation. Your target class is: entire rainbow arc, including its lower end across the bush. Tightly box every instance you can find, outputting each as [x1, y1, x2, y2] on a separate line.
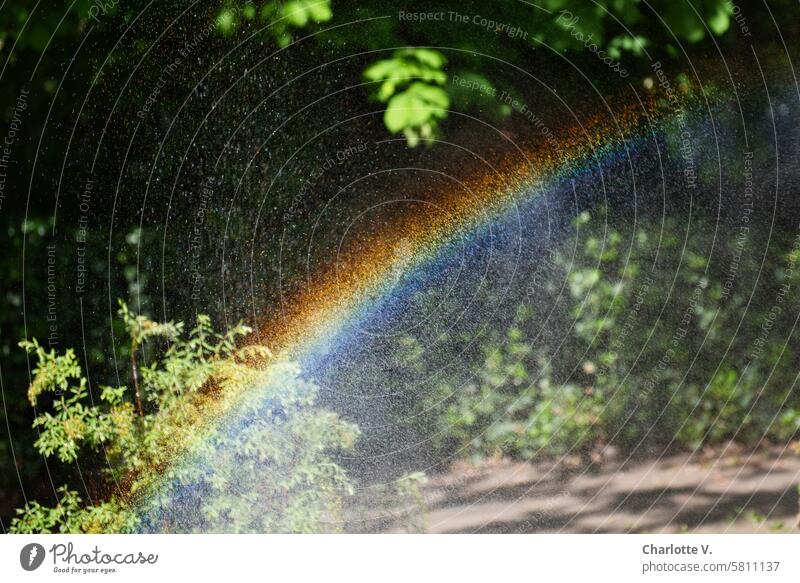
[131, 89, 708, 522]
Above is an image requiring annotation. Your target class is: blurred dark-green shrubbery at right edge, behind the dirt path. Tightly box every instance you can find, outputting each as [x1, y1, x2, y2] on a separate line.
[562, 214, 800, 448]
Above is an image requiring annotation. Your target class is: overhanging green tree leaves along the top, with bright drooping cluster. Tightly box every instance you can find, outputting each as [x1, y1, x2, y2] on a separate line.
[205, 0, 752, 146]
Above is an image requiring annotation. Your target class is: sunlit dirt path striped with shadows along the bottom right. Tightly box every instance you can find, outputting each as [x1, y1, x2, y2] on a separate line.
[386, 448, 800, 533]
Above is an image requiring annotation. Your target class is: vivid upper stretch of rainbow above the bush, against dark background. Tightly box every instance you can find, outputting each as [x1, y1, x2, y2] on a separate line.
[258, 100, 676, 362]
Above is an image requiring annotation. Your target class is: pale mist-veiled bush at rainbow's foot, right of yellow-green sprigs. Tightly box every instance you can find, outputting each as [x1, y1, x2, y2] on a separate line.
[143, 363, 358, 532]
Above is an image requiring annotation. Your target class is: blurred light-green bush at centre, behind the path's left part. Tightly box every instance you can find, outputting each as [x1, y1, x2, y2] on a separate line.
[427, 307, 603, 459]
